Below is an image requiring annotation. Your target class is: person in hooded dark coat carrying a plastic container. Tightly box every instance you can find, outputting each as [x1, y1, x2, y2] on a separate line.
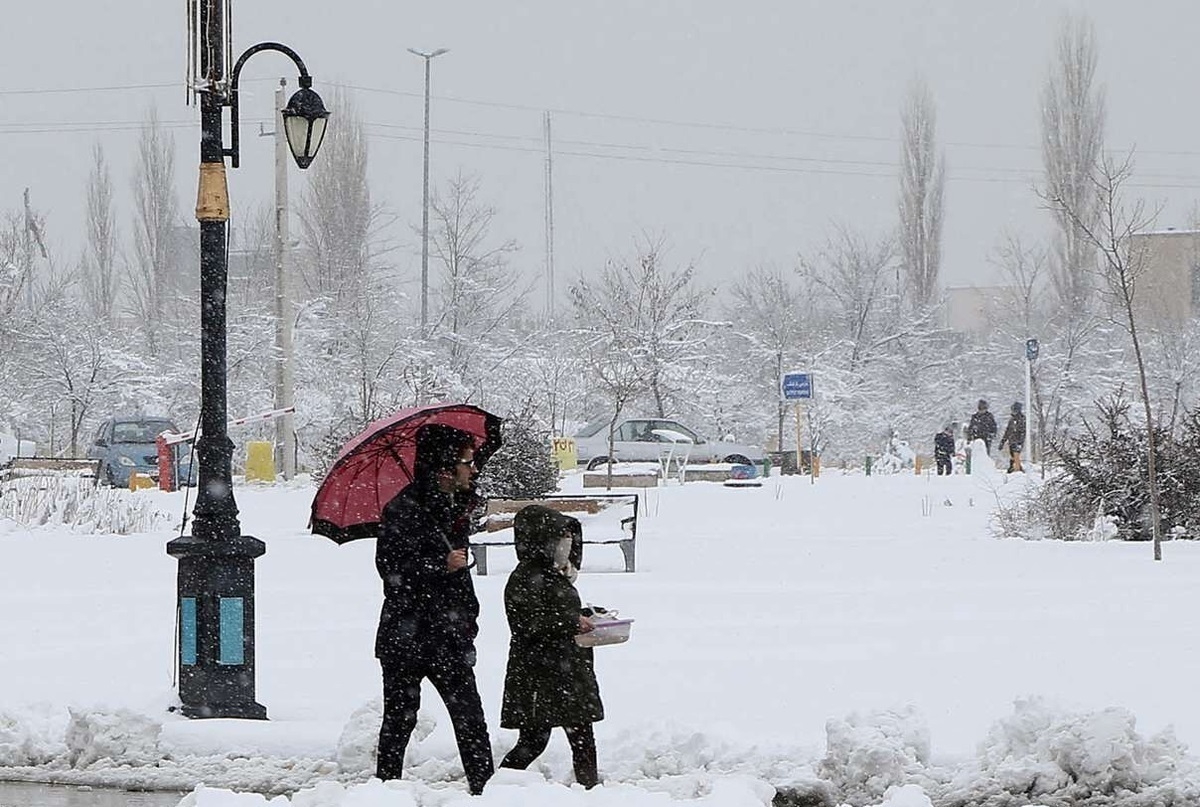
[500, 504, 604, 788]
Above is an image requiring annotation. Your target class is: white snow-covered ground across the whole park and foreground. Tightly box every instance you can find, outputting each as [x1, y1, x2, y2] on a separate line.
[0, 463, 1200, 807]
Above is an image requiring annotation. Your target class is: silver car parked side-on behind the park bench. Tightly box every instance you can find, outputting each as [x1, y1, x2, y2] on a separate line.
[575, 417, 762, 471]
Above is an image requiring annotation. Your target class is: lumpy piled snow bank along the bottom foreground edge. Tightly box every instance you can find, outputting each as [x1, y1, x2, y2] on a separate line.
[0, 699, 1200, 807]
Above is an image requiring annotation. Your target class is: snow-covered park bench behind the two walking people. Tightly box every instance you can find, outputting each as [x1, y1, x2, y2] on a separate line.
[470, 494, 637, 574]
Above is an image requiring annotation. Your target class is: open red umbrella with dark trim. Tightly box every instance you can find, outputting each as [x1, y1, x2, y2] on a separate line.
[308, 404, 500, 544]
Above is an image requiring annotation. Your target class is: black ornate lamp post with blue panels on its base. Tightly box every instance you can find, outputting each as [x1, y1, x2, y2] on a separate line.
[167, 0, 329, 719]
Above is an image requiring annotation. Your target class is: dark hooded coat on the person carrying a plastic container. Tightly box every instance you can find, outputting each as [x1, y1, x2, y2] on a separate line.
[500, 504, 604, 729]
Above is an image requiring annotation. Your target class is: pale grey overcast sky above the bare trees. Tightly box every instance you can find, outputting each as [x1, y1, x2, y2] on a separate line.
[0, 0, 1200, 302]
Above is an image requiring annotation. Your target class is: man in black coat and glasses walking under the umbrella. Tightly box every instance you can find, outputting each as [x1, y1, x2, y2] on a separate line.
[376, 424, 494, 794]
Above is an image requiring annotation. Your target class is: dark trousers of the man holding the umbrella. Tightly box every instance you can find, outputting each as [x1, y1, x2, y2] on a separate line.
[376, 658, 496, 795]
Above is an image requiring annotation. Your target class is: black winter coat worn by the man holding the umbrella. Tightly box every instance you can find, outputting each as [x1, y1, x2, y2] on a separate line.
[376, 483, 479, 662]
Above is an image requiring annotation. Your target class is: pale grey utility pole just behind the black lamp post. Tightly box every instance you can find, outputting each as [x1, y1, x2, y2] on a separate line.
[275, 78, 296, 479]
